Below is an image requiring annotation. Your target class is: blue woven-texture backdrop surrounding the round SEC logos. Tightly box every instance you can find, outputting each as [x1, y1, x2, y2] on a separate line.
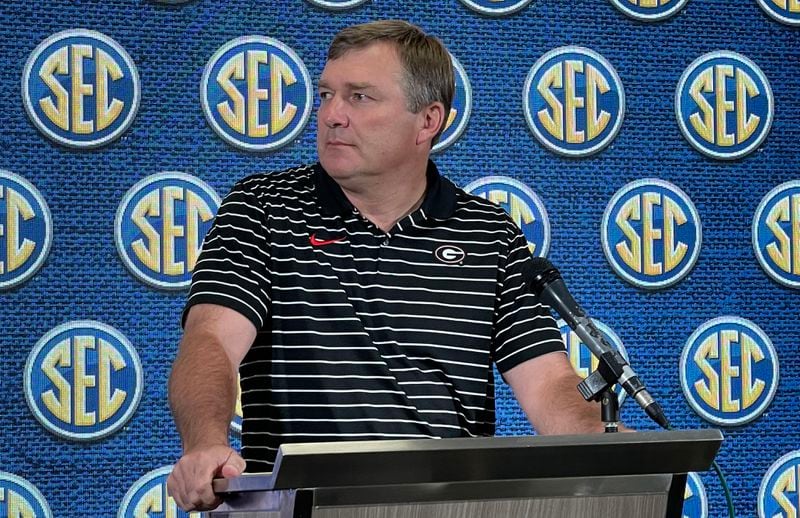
[0, 0, 800, 517]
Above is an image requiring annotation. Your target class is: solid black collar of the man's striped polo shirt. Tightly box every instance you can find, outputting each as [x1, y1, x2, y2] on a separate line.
[314, 160, 457, 219]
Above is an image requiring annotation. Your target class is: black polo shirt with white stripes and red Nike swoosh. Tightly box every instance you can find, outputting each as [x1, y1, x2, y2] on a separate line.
[184, 162, 564, 472]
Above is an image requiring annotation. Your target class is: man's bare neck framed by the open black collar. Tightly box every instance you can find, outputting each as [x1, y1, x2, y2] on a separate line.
[340, 162, 427, 232]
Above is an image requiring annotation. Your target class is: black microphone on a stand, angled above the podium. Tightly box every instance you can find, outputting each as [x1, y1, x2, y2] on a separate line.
[530, 257, 669, 428]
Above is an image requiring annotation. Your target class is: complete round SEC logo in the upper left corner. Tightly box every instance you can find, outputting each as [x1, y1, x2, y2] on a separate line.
[22, 29, 140, 148]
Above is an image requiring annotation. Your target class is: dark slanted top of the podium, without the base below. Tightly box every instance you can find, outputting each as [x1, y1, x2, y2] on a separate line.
[213, 430, 723, 494]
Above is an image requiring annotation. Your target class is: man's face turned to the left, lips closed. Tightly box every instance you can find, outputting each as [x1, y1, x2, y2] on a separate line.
[317, 43, 430, 184]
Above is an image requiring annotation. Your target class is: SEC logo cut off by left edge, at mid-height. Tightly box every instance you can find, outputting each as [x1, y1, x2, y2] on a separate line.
[0, 170, 53, 290]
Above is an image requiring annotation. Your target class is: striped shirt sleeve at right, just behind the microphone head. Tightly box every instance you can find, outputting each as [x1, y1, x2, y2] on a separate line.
[492, 220, 566, 374]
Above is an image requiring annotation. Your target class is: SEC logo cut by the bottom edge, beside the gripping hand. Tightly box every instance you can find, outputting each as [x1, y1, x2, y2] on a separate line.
[117, 466, 202, 518]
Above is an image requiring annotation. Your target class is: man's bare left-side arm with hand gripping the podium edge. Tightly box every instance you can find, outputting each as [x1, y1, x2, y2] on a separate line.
[167, 304, 256, 511]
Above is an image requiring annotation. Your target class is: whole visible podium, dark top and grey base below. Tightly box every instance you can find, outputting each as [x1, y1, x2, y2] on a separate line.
[208, 430, 722, 518]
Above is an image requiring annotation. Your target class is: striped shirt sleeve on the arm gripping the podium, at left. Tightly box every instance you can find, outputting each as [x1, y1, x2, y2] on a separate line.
[181, 180, 271, 330]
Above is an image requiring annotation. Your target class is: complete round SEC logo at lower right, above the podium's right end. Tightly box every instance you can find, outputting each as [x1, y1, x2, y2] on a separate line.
[680, 316, 778, 426]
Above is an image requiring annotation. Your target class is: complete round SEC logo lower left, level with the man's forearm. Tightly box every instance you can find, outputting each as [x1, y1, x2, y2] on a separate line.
[24, 320, 144, 441]
